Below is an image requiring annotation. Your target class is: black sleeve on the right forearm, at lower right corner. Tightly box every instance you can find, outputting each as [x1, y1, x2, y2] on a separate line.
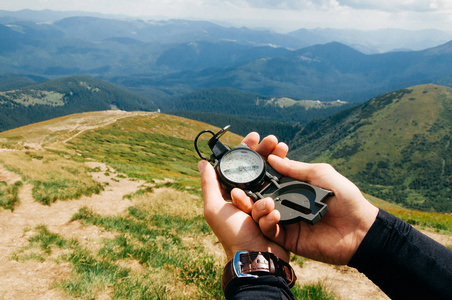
[348, 210, 452, 299]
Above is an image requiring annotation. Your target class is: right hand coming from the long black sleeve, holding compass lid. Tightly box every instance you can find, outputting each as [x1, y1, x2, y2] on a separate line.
[236, 155, 378, 265]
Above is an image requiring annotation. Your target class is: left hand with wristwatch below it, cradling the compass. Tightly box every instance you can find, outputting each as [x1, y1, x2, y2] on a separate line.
[198, 132, 289, 262]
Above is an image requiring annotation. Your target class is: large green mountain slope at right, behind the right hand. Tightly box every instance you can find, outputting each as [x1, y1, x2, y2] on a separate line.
[291, 85, 452, 212]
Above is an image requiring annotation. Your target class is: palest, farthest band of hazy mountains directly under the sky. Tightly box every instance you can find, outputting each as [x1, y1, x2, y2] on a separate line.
[0, 10, 452, 54]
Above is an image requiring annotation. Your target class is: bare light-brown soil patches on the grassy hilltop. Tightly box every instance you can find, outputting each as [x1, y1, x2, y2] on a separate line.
[0, 157, 452, 299]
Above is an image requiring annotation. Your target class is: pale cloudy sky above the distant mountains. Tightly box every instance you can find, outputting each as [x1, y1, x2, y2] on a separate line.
[0, 0, 452, 32]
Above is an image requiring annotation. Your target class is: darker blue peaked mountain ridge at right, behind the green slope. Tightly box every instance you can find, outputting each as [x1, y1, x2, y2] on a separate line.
[147, 42, 452, 102]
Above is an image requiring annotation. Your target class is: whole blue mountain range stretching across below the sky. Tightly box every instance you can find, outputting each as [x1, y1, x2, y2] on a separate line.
[0, 11, 452, 102]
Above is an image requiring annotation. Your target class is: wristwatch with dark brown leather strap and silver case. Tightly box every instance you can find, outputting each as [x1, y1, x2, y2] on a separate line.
[221, 251, 297, 293]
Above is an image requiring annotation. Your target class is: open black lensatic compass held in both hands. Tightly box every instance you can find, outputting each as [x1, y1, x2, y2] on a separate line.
[195, 125, 333, 225]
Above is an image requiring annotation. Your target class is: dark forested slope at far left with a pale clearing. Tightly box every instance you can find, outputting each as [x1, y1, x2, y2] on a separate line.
[0, 76, 155, 131]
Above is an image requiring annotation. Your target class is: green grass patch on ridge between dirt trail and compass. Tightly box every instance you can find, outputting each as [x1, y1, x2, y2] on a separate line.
[67, 114, 241, 187]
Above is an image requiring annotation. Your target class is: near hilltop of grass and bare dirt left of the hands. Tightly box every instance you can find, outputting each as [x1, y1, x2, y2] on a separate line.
[0, 111, 240, 299]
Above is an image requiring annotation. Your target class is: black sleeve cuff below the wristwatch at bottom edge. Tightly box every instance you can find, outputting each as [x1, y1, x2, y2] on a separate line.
[224, 276, 295, 300]
